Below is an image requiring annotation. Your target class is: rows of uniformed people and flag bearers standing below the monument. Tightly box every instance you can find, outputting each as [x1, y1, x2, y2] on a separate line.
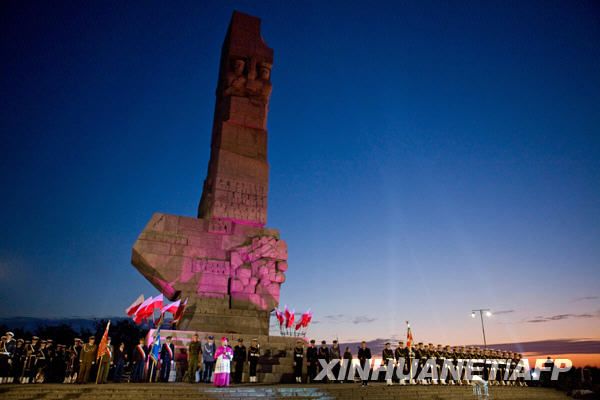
[0, 332, 525, 386]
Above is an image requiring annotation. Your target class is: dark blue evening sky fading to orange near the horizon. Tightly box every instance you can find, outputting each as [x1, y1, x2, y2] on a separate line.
[0, 1, 600, 343]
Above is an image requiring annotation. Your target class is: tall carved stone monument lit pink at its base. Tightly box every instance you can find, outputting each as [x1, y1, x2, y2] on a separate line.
[131, 11, 288, 335]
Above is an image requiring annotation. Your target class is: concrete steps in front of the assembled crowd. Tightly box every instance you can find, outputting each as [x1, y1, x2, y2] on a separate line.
[0, 383, 568, 400]
